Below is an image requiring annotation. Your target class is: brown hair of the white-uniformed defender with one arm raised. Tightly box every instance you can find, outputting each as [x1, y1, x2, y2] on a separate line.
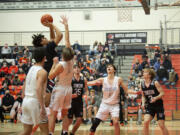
[62, 47, 75, 61]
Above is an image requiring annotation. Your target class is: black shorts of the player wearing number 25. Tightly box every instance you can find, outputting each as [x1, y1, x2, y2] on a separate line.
[68, 103, 83, 119]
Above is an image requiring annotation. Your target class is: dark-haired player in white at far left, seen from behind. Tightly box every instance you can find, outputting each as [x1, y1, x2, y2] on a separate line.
[21, 47, 48, 135]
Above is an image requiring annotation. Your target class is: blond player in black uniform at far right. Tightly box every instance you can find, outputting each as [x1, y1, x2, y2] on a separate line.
[141, 69, 168, 135]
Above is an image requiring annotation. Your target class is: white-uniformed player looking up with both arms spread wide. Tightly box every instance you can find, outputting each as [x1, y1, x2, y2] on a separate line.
[87, 64, 138, 135]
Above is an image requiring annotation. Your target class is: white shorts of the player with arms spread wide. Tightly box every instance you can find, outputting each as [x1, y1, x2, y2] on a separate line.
[96, 102, 119, 121]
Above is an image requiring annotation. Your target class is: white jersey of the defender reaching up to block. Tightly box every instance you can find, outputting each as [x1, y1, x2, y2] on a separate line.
[56, 60, 74, 87]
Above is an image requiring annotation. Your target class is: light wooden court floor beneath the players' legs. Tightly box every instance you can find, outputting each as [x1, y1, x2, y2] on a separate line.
[0, 121, 180, 135]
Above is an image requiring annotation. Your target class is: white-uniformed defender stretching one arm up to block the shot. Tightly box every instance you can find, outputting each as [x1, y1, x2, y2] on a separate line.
[49, 16, 74, 135]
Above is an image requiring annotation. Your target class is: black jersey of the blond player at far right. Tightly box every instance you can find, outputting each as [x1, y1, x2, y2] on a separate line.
[141, 80, 163, 106]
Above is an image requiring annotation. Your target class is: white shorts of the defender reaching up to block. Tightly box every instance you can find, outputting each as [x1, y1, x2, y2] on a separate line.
[49, 86, 72, 111]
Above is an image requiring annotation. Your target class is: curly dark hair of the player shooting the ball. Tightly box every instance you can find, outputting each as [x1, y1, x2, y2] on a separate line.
[32, 34, 44, 47]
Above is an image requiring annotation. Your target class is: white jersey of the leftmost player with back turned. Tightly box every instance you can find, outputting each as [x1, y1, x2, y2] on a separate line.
[25, 65, 43, 98]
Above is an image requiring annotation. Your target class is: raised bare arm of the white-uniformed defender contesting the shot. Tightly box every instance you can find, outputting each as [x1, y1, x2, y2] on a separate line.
[61, 16, 71, 48]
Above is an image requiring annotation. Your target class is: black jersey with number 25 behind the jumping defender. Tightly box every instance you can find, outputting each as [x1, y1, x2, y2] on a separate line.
[71, 76, 85, 103]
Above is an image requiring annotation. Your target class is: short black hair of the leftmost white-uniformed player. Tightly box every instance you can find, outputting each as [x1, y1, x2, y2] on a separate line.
[33, 47, 46, 62]
